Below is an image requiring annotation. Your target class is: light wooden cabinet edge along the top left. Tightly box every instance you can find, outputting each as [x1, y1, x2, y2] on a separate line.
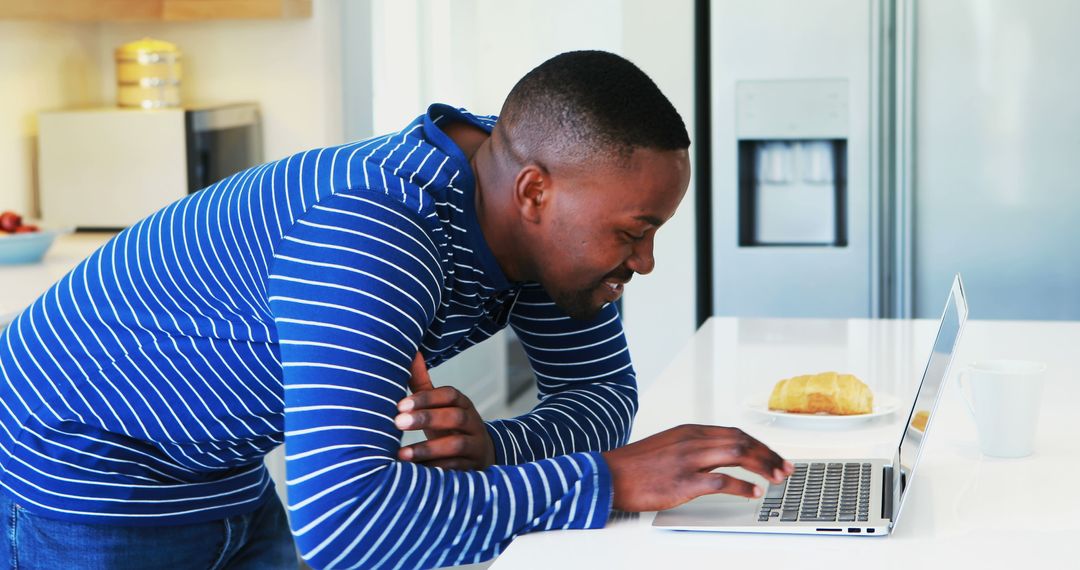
[0, 0, 312, 22]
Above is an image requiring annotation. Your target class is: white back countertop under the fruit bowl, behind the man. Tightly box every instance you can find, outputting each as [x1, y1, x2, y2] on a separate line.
[0, 232, 116, 323]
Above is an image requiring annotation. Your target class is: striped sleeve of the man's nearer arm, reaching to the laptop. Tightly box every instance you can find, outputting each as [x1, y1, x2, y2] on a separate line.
[268, 192, 611, 568]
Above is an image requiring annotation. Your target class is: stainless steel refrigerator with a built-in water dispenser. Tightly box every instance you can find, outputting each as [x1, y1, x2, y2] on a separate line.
[707, 0, 1080, 320]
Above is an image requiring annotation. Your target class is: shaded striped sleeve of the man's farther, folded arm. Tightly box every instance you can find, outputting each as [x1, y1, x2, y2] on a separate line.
[487, 284, 637, 465]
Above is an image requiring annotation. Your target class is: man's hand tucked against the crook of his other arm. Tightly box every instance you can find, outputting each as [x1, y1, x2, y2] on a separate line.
[394, 353, 495, 470]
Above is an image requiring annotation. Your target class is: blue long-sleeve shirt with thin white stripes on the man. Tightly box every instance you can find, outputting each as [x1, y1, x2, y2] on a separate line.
[0, 105, 637, 568]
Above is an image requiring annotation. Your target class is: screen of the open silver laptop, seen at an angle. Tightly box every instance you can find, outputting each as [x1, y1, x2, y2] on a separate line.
[892, 275, 968, 521]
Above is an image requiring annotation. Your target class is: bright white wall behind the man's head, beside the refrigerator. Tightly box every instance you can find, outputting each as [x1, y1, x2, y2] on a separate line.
[360, 0, 696, 392]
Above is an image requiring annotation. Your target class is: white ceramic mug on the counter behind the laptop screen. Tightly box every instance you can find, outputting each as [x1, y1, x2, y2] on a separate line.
[959, 361, 1047, 458]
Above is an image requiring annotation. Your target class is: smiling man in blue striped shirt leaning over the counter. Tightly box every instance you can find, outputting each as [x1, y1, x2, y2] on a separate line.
[0, 52, 791, 568]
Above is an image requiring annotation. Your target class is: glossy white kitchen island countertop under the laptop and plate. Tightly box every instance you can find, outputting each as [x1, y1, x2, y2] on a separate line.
[492, 318, 1080, 570]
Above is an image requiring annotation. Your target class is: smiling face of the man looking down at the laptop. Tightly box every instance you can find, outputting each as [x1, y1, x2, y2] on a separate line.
[534, 149, 690, 318]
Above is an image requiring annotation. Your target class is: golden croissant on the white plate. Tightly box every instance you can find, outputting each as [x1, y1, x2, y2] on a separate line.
[769, 372, 874, 416]
